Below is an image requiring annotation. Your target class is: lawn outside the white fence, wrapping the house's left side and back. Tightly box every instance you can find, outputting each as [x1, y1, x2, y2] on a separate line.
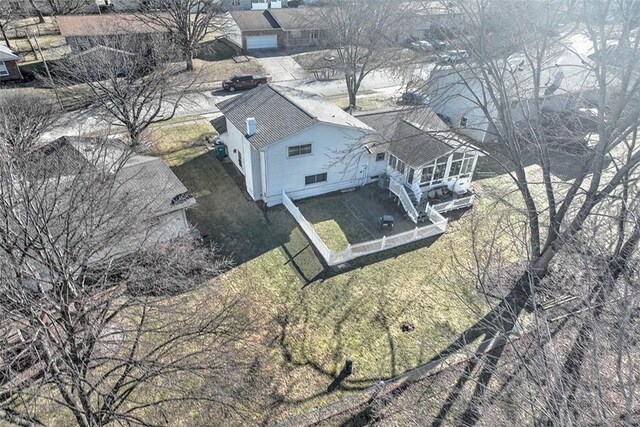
[150, 123, 524, 424]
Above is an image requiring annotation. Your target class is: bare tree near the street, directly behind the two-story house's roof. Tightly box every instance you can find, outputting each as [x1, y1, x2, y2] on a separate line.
[309, 0, 405, 108]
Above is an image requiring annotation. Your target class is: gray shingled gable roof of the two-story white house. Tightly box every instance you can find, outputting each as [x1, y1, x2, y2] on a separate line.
[217, 84, 373, 149]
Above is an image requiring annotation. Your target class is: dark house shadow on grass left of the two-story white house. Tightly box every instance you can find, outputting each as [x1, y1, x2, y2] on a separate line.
[172, 152, 324, 283]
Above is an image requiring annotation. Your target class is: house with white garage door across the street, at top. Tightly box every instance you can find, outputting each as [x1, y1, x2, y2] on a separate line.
[229, 7, 324, 50]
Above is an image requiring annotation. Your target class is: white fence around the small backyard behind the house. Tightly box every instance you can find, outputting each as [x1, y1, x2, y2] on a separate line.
[282, 191, 448, 266]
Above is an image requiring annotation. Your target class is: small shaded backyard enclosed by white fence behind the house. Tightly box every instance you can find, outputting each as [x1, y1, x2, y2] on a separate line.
[282, 184, 448, 266]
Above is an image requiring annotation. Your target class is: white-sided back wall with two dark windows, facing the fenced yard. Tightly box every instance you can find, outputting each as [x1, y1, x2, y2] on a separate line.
[265, 124, 371, 206]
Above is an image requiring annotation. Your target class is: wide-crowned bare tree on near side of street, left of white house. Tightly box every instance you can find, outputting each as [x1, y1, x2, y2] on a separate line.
[54, 35, 197, 147]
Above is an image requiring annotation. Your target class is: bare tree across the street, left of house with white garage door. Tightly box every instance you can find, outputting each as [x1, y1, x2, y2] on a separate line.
[139, 0, 228, 71]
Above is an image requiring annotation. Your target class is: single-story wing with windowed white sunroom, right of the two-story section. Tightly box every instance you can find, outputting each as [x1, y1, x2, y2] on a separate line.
[356, 108, 484, 214]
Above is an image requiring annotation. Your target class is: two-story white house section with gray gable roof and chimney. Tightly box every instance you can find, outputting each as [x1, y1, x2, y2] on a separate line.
[217, 84, 385, 206]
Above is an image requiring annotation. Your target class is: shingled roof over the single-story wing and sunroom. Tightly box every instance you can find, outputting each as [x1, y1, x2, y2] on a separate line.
[357, 108, 461, 169]
